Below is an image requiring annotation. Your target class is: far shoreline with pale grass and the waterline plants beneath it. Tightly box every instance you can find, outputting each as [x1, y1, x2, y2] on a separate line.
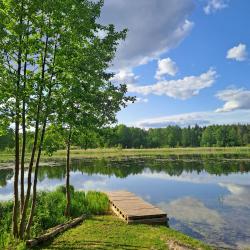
[0, 147, 250, 170]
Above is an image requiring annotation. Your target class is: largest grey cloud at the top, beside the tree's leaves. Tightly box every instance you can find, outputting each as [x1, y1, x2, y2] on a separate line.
[100, 0, 195, 69]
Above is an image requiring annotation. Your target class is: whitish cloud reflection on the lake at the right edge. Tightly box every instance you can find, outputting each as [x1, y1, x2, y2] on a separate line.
[219, 183, 250, 208]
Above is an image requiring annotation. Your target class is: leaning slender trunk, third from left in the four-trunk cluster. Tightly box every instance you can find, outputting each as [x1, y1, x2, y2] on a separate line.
[19, 36, 49, 239]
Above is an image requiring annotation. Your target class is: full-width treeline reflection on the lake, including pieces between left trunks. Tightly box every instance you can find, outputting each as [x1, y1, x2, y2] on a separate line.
[0, 155, 250, 187]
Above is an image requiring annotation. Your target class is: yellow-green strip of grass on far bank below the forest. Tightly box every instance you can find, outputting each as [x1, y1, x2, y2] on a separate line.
[0, 147, 250, 163]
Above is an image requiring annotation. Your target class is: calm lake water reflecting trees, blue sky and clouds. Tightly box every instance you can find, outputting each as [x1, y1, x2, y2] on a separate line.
[0, 155, 250, 249]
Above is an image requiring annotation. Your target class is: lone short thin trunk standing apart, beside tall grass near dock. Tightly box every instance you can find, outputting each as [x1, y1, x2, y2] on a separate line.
[64, 128, 72, 217]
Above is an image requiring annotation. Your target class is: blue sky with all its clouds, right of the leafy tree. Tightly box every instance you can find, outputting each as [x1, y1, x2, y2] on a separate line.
[101, 0, 250, 128]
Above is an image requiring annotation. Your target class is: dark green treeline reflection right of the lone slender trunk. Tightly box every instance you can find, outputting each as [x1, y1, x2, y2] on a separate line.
[72, 156, 250, 178]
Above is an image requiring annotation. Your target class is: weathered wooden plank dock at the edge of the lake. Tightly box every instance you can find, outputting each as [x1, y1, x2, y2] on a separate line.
[106, 191, 168, 224]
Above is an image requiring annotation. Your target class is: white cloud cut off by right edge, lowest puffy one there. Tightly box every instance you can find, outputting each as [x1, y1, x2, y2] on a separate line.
[216, 88, 250, 112]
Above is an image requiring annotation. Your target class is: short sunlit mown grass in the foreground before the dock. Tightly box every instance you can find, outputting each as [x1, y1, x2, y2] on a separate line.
[36, 215, 211, 250]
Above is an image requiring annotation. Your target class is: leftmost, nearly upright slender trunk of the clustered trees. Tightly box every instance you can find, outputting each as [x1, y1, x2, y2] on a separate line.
[12, 2, 23, 238]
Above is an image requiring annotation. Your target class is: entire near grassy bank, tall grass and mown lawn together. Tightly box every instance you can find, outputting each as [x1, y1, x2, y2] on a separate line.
[0, 192, 213, 250]
